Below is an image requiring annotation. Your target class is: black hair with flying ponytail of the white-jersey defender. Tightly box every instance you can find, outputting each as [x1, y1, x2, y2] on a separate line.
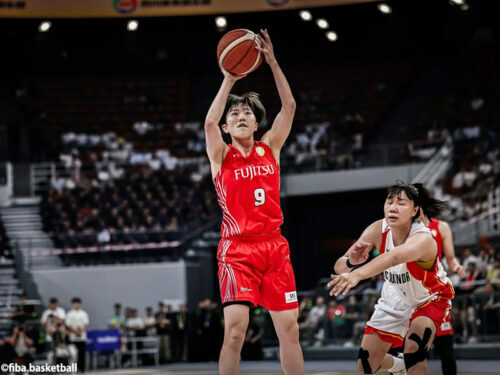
[387, 180, 448, 220]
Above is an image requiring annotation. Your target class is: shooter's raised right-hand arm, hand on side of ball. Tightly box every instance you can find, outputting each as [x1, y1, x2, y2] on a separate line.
[256, 29, 296, 155]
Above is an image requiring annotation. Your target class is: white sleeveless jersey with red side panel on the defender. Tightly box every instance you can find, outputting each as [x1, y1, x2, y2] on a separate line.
[380, 219, 454, 311]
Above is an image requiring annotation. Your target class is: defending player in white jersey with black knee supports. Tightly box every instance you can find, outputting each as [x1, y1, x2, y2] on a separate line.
[328, 182, 454, 374]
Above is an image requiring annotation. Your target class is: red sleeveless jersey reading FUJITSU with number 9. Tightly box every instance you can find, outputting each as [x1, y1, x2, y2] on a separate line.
[213, 141, 283, 238]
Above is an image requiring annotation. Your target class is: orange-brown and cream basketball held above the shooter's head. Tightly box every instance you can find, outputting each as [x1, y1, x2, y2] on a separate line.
[217, 29, 262, 75]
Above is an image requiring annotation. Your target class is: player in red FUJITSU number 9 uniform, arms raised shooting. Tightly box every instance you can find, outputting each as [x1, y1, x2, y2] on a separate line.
[205, 30, 304, 375]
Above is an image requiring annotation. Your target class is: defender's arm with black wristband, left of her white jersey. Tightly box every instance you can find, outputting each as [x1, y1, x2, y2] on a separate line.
[334, 220, 382, 274]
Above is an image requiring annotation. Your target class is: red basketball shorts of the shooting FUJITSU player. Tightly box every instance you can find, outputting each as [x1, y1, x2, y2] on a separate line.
[217, 230, 298, 311]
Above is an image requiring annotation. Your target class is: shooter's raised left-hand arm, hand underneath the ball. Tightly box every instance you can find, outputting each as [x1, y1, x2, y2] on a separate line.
[205, 67, 245, 177]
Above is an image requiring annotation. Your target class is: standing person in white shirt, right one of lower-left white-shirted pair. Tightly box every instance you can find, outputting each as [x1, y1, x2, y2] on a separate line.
[66, 297, 90, 372]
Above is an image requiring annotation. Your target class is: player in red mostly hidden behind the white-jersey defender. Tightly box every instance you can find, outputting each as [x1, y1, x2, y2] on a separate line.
[420, 213, 465, 375]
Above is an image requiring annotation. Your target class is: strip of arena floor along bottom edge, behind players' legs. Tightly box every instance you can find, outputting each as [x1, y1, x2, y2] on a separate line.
[87, 361, 500, 375]
